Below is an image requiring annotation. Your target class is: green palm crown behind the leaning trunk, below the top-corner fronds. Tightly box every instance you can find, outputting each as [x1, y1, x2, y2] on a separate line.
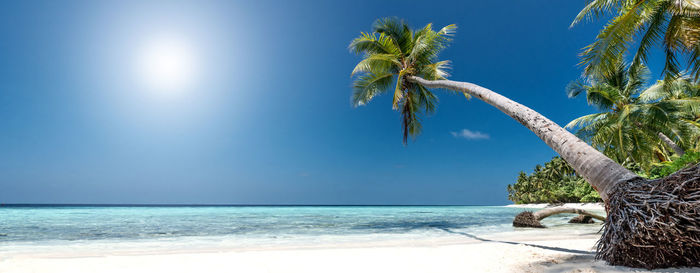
[565, 63, 689, 170]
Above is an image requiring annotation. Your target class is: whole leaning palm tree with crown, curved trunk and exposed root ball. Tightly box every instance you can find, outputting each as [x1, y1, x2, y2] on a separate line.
[349, 18, 700, 267]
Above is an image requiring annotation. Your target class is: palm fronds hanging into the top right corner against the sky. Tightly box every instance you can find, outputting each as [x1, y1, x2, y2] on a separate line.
[571, 0, 700, 79]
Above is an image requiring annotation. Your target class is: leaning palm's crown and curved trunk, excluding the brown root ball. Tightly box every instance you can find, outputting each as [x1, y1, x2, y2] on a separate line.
[350, 18, 639, 202]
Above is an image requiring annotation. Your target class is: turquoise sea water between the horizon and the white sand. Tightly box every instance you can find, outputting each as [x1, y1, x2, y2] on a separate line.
[0, 206, 600, 246]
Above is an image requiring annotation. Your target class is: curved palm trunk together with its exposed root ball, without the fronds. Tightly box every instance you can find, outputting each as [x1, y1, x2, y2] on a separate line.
[406, 76, 700, 269]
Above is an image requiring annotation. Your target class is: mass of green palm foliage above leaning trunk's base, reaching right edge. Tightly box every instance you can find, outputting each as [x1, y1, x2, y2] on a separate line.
[566, 63, 700, 171]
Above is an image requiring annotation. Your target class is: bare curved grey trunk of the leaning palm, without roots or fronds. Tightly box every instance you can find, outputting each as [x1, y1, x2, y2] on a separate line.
[407, 76, 639, 202]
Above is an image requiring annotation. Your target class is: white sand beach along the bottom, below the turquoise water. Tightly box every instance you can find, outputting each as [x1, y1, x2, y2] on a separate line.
[0, 224, 700, 273]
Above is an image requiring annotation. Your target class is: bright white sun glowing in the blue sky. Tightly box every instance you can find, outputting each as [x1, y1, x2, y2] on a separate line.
[137, 38, 197, 92]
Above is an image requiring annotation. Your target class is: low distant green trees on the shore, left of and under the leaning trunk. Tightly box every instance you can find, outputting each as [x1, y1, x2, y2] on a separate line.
[507, 156, 601, 204]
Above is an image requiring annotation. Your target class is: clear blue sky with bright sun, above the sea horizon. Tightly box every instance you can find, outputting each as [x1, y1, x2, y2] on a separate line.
[0, 0, 660, 205]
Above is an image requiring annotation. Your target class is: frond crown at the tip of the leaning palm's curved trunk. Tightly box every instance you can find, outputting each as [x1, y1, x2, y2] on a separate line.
[349, 18, 457, 144]
